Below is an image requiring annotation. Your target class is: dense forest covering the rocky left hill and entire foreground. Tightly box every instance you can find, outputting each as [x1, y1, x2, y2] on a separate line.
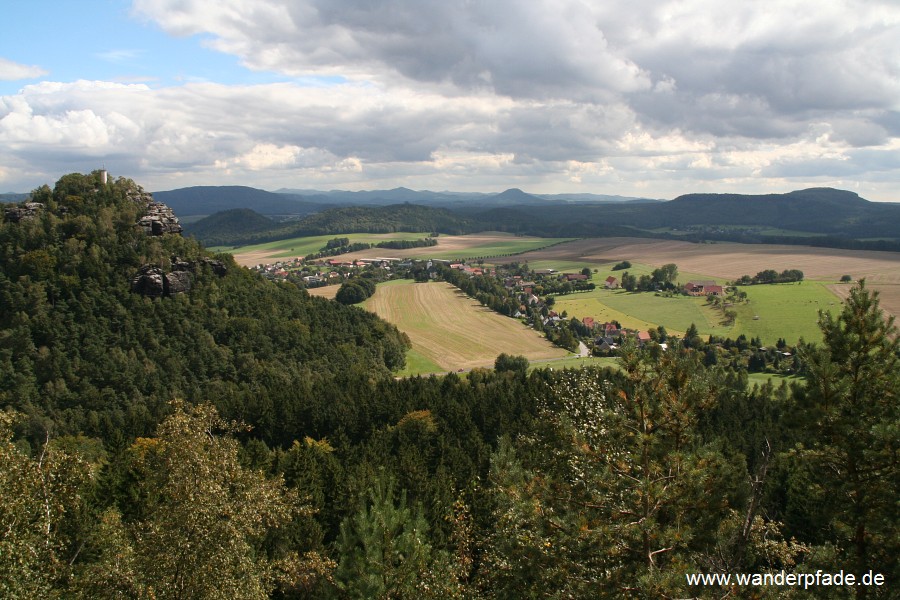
[0, 172, 900, 598]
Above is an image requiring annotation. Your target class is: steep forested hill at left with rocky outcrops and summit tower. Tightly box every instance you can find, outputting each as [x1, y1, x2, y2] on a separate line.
[0, 173, 408, 440]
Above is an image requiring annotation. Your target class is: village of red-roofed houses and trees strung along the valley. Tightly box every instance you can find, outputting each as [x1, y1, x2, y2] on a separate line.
[243, 247, 791, 368]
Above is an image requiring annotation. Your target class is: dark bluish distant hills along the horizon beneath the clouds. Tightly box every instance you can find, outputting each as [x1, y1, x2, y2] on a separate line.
[174, 183, 900, 250]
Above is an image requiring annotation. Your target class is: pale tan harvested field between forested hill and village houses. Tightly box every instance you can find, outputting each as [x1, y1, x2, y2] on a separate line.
[363, 280, 570, 374]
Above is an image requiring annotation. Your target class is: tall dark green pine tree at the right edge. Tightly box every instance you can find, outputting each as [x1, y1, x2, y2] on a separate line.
[797, 280, 900, 598]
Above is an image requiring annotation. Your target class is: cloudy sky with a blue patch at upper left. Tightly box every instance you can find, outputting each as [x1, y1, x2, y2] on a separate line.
[0, 0, 900, 202]
